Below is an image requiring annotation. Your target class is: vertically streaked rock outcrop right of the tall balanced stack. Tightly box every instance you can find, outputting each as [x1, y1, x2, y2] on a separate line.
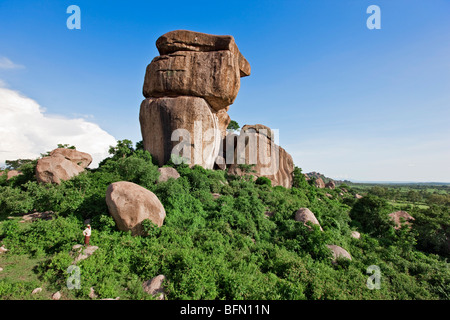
[225, 124, 294, 188]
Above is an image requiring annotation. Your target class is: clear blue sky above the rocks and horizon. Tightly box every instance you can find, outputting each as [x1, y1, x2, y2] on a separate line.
[0, 0, 450, 182]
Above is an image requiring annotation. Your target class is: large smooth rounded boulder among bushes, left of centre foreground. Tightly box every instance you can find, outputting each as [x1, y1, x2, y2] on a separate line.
[106, 181, 166, 235]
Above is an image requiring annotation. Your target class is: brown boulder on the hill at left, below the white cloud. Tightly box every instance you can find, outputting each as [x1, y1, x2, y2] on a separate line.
[36, 148, 92, 184]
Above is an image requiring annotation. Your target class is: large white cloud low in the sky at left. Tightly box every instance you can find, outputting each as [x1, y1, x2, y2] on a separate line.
[0, 88, 116, 168]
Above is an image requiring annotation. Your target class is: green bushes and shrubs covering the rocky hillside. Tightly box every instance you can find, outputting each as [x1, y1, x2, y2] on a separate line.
[0, 140, 450, 299]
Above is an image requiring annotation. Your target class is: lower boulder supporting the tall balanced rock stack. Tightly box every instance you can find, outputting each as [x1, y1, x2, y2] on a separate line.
[139, 96, 221, 169]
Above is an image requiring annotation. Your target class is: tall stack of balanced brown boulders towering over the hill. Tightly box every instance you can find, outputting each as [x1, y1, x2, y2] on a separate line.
[139, 30, 250, 169]
